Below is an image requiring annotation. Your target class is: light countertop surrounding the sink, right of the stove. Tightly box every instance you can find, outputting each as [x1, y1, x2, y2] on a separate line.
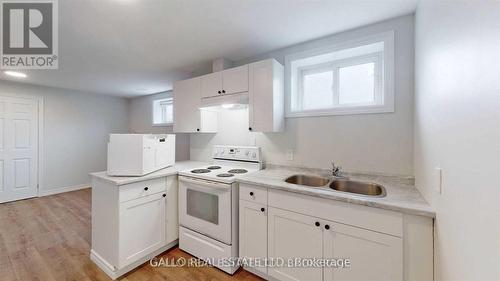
[237, 166, 435, 218]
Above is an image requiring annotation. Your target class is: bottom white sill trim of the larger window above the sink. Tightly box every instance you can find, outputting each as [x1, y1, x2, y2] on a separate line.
[285, 106, 394, 118]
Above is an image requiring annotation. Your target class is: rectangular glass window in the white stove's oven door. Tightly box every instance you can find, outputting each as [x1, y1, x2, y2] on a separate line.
[186, 189, 219, 224]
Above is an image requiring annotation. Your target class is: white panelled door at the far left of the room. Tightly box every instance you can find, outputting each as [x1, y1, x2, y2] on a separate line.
[0, 97, 38, 203]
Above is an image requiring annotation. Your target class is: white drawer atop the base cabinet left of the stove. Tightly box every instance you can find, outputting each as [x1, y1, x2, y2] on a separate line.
[120, 178, 167, 202]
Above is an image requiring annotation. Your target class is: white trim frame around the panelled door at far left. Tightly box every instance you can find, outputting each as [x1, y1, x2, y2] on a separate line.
[0, 93, 45, 199]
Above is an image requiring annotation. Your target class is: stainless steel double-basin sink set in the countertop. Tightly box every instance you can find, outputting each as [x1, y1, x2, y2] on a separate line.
[285, 175, 386, 197]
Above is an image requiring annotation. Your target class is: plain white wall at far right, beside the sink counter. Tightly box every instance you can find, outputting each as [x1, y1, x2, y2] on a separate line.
[415, 0, 500, 281]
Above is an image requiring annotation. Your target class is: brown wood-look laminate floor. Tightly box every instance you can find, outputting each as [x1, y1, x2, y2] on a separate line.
[0, 189, 262, 281]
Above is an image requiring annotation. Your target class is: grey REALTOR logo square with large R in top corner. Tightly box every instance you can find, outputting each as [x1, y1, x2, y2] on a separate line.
[0, 0, 58, 69]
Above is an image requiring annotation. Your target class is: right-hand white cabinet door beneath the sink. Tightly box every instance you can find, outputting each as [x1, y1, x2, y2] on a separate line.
[324, 222, 403, 281]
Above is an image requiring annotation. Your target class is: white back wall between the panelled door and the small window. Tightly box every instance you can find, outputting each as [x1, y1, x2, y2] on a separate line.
[0, 81, 128, 194]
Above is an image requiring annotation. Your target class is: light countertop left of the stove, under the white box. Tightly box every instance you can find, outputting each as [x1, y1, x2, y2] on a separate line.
[90, 161, 207, 185]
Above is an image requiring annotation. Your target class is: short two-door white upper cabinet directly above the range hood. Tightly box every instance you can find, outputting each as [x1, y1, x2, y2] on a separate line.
[201, 65, 248, 98]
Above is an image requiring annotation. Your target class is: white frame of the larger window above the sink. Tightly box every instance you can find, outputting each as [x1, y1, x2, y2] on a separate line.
[285, 31, 394, 118]
